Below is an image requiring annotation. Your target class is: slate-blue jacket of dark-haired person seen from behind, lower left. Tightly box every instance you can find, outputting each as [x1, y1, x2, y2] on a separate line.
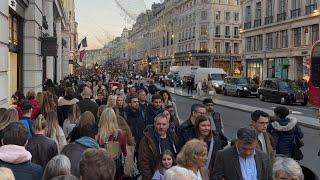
[61, 136, 99, 178]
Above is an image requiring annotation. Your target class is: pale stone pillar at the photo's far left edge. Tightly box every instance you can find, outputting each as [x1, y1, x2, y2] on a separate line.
[0, 0, 9, 108]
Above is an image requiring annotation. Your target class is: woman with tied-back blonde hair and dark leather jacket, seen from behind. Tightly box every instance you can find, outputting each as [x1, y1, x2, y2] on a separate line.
[26, 114, 58, 168]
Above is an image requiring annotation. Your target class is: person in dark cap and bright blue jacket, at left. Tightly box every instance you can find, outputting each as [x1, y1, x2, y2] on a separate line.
[19, 101, 32, 139]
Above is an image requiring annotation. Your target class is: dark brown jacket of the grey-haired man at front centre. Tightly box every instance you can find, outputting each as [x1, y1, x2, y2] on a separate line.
[138, 125, 179, 180]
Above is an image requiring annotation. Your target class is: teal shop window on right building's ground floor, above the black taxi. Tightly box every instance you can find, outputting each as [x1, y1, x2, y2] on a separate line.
[267, 58, 289, 79]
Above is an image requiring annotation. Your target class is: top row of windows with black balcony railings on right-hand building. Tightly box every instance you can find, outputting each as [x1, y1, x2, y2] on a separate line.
[244, 0, 317, 29]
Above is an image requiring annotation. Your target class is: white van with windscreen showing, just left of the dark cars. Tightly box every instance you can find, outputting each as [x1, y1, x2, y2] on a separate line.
[194, 68, 226, 92]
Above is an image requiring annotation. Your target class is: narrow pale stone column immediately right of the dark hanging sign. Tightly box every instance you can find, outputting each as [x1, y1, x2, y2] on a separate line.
[55, 18, 62, 82]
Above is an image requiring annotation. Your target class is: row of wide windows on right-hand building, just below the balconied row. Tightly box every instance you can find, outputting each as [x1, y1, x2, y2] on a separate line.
[245, 24, 319, 52]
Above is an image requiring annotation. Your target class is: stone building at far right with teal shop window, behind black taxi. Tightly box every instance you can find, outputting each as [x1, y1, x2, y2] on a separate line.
[241, 0, 320, 80]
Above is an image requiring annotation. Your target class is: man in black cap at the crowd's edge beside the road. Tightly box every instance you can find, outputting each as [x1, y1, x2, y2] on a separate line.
[202, 98, 224, 133]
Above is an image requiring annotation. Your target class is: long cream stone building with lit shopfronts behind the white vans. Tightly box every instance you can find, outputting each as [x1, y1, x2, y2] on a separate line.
[123, 0, 242, 75]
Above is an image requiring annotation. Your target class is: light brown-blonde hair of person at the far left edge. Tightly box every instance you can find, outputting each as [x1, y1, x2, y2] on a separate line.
[0, 108, 19, 141]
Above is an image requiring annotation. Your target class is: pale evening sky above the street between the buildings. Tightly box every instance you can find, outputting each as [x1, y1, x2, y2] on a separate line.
[75, 0, 161, 49]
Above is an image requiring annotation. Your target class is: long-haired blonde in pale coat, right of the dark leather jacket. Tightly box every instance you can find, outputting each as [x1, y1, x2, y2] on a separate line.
[46, 111, 67, 153]
